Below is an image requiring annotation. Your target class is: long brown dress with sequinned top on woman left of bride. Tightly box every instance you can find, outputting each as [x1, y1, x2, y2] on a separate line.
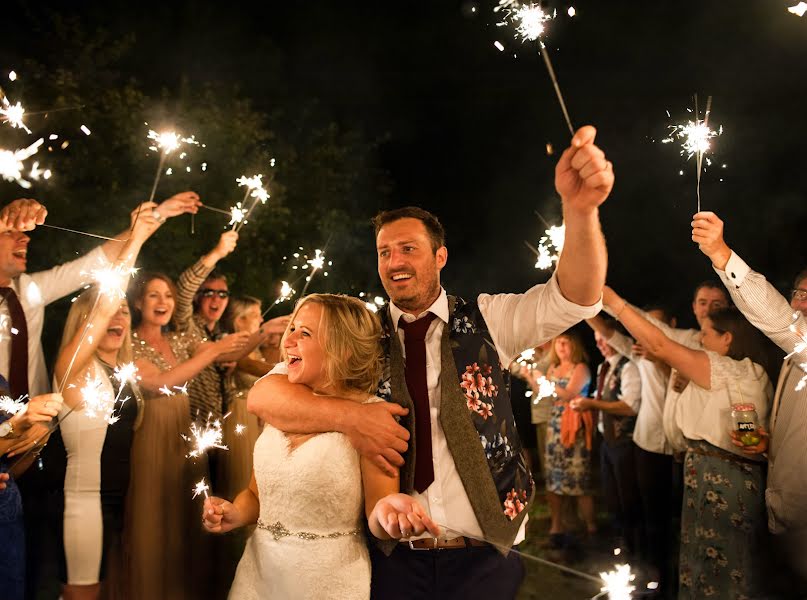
[124, 332, 209, 600]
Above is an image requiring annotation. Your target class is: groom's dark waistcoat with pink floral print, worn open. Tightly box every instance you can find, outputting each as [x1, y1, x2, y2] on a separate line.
[378, 296, 535, 551]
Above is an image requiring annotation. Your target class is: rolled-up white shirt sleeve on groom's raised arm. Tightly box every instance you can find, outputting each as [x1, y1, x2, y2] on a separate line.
[477, 274, 602, 365]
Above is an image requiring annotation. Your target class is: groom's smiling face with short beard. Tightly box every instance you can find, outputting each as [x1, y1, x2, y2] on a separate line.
[376, 217, 448, 314]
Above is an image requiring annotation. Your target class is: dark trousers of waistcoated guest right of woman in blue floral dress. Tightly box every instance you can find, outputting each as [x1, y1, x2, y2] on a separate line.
[600, 440, 641, 554]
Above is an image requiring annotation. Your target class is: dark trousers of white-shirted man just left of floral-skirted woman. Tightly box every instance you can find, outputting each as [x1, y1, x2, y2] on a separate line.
[634, 446, 681, 590]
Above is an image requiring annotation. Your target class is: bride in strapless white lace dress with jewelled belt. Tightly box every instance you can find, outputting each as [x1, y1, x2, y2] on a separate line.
[202, 294, 440, 600]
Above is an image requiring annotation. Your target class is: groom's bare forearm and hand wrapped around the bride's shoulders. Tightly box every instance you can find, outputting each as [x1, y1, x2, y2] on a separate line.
[247, 374, 409, 475]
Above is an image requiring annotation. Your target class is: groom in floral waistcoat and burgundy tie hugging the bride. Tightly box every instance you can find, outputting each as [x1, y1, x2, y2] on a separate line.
[249, 127, 614, 599]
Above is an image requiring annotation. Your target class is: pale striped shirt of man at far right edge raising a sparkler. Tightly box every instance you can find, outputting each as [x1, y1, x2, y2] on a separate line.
[715, 252, 807, 533]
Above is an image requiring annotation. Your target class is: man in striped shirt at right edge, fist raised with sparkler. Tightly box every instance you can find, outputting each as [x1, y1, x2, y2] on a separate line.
[692, 212, 807, 598]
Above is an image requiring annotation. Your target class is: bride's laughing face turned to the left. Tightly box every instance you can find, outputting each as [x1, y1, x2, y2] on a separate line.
[283, 302, 326, 391]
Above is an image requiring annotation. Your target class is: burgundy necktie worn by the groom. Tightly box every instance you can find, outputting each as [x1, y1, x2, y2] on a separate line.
[398, 313, 434, 492]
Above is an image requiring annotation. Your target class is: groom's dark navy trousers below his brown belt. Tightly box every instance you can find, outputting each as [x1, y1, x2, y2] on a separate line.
[369, 542, 524, 600]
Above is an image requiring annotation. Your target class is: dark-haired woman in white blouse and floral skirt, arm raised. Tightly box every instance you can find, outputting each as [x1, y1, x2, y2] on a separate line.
[603, 286, 784, 598]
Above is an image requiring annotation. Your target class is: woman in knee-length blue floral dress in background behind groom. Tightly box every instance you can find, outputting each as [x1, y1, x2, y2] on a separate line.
[546, 331, 597, 548]
